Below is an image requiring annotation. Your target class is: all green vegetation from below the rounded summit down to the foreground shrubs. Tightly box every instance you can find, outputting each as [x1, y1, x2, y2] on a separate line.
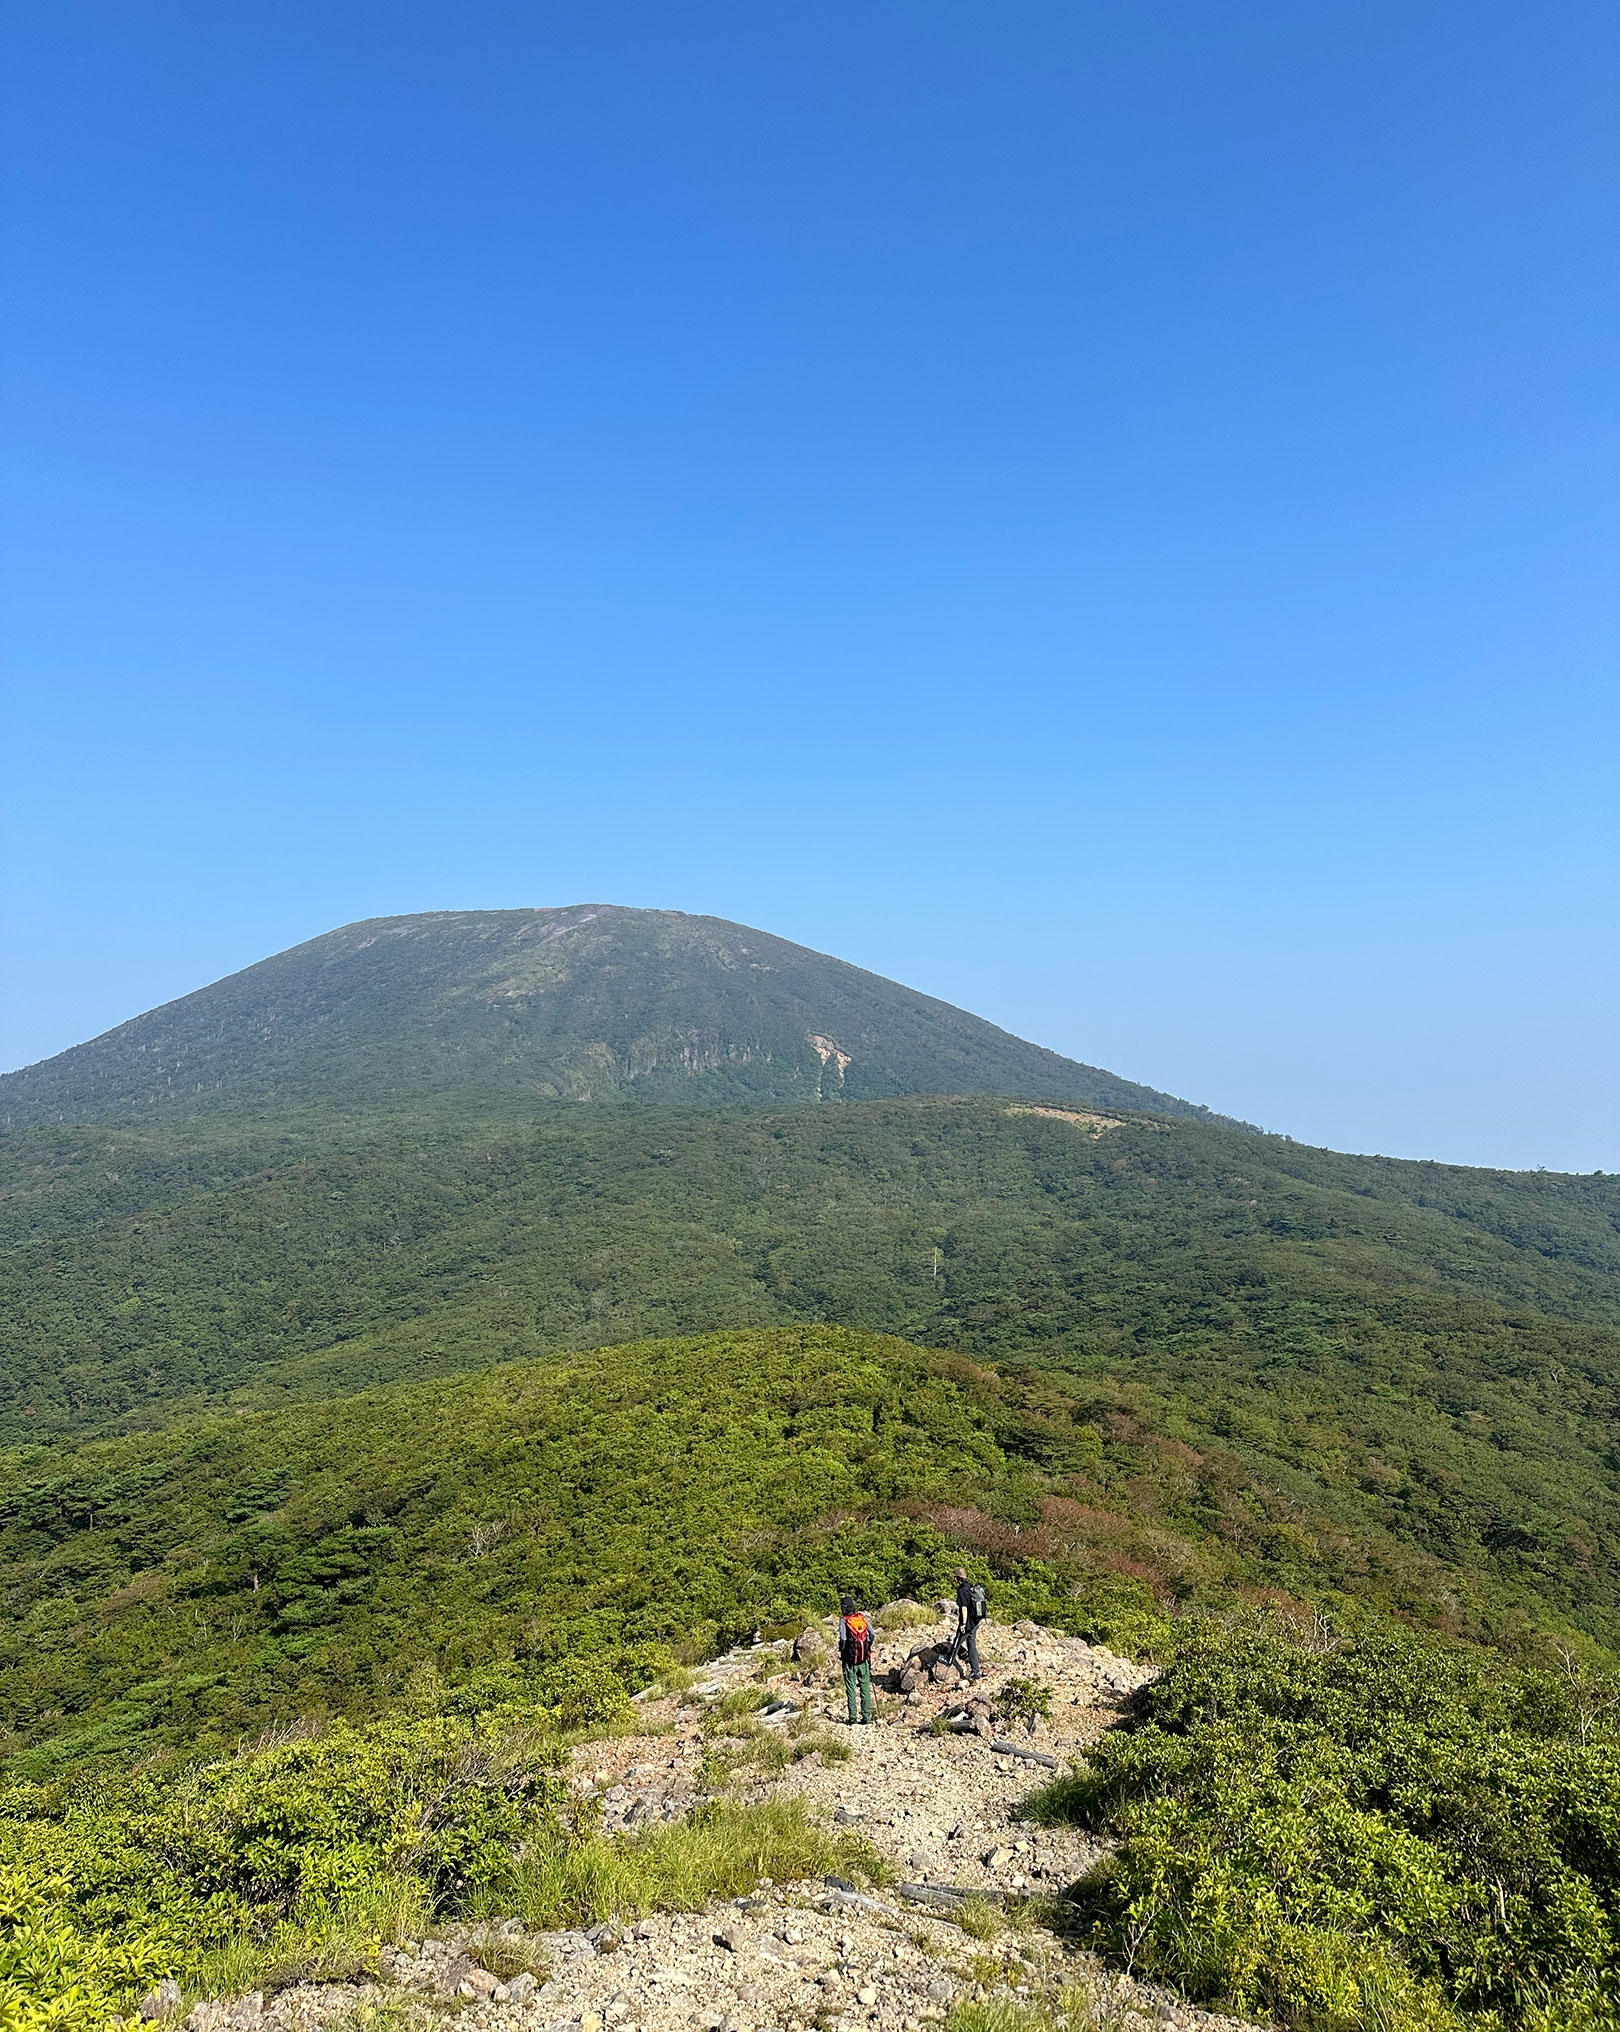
[0, 1048, 1620, 2032]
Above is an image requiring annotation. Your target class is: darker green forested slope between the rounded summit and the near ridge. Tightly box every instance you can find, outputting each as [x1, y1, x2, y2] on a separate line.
[12, 1099, 1620, 1435]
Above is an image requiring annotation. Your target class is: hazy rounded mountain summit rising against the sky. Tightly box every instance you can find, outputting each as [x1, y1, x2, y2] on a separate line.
[0, 904, 1209, 1128]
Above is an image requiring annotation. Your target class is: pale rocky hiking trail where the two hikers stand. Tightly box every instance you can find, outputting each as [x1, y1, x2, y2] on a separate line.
[170, 1603, 1252, 2032]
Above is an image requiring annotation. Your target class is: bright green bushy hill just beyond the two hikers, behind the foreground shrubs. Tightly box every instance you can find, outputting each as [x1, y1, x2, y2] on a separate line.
[0, 1327, 1593, 1772]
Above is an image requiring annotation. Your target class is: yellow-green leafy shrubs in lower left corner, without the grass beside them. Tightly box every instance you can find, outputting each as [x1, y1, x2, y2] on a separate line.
[0, 1668, 624, 2028]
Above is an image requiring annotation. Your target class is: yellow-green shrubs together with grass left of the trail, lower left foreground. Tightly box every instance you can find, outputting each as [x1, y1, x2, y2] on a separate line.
[0, 1670, 876, 2032]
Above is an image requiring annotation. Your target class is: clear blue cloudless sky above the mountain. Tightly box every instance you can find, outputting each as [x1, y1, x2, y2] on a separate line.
[0, 0, 1620, 1170]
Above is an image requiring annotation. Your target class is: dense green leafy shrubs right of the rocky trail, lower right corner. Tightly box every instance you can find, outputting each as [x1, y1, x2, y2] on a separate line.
[1035, 1622, 1620, 2032]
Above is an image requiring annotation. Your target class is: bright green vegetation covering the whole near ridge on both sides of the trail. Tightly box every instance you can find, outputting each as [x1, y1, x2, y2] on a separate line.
[0, 1327, 1620, 2032]
